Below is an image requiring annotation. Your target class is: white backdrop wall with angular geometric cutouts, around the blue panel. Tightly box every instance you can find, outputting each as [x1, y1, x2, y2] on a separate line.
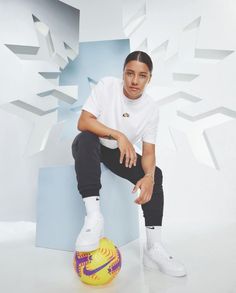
[0, 0, 236, 221]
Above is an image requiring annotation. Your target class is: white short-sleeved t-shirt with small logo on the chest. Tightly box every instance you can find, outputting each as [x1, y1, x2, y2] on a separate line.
[82, 77, 158, 149]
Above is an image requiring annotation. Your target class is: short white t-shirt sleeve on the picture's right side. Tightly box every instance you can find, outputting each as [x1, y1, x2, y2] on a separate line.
[142, 105, 159, 144]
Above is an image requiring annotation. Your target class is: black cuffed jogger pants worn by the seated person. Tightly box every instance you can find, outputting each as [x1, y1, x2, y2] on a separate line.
[72, 131, 164, 226]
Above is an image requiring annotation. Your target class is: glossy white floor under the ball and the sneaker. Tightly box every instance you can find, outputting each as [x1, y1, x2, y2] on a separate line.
[0, 222, 236, 293]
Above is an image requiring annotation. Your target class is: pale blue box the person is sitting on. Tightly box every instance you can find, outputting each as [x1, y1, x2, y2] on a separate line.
[36, 164, 139, 251]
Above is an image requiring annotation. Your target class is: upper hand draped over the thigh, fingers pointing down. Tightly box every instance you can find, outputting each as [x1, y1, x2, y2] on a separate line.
[117, 134, 137, 168]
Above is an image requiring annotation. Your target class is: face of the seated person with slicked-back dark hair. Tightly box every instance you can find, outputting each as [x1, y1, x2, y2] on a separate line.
[123, 60, 151, 99]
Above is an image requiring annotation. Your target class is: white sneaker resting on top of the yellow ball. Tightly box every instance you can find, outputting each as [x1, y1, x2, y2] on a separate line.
[75, 214, 104, 251]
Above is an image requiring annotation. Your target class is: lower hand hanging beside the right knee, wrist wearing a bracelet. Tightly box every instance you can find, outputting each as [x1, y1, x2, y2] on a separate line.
[132, 176, 154, 204]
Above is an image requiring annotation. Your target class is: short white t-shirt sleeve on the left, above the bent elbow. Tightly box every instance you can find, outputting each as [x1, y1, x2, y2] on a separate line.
[82, 80, 104, 117]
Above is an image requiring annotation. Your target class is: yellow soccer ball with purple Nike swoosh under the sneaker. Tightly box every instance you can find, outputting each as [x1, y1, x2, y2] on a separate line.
[73, 237, 121, 286]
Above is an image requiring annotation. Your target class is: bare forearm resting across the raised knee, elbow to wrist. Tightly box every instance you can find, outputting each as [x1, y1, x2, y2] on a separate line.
[77, 118, 122, 140]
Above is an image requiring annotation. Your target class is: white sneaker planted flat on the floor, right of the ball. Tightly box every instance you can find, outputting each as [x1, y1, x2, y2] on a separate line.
[143, 243, 187, 277]
